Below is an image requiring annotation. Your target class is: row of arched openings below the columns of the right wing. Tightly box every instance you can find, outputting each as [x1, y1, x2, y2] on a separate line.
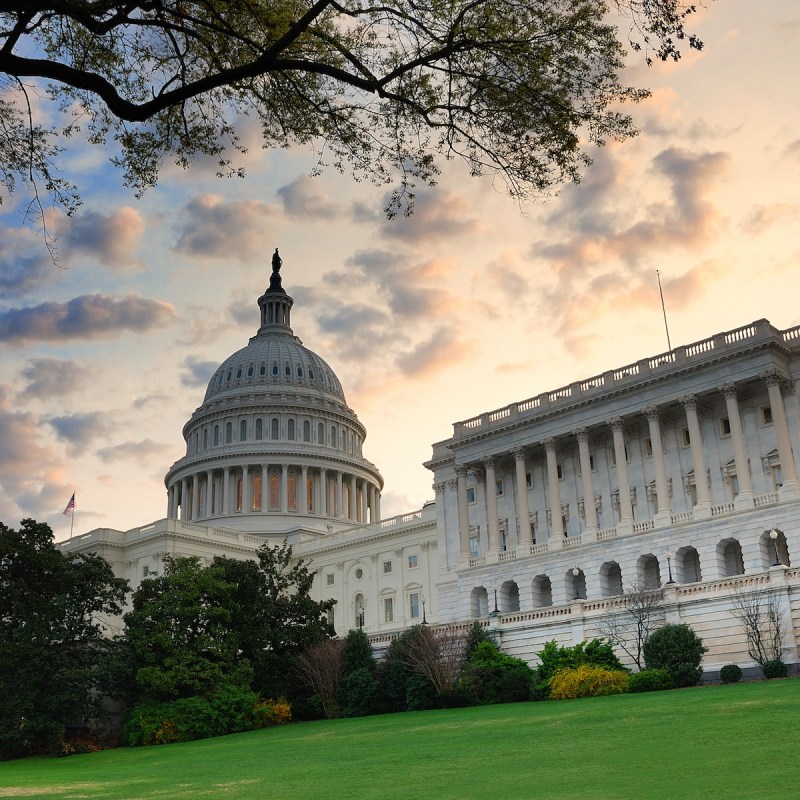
[470, 531, 790, 617]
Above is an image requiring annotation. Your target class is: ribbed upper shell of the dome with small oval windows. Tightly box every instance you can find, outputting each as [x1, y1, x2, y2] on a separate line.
[203, 333, 346, 405]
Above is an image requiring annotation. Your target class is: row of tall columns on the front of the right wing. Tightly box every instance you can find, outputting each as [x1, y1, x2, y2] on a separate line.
[446, 371, 798, 557]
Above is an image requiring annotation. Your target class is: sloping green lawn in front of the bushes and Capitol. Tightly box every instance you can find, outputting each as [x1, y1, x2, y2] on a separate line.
[0, 679, 800, 800]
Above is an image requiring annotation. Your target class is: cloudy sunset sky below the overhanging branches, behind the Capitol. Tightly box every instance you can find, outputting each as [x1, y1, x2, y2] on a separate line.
[0, 0, 800, 540]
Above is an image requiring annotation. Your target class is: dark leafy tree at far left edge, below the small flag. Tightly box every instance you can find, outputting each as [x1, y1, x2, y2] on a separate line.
[0, 519, 128, 758]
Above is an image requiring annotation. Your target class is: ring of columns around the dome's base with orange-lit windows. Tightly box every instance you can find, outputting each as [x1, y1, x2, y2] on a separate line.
[167, 463, 381, 524]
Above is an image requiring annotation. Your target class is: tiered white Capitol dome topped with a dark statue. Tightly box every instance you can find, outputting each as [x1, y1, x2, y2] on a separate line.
[165, 249, 383, 535]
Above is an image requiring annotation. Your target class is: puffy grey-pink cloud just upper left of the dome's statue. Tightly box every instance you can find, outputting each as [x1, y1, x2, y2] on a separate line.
[176, 194, 275, 261]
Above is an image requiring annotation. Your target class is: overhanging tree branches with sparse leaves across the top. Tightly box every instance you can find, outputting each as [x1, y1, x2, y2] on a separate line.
[0, 0, 702, 219]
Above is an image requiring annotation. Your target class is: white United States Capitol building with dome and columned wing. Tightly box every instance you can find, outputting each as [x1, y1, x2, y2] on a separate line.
[61, 251, 800, 674]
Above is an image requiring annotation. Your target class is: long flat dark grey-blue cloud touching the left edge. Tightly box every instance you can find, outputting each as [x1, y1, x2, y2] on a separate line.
[0, 294, 175, 344]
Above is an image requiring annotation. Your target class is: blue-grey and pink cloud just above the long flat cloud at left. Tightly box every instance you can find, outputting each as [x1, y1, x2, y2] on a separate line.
[55, 206, 144, 269]
